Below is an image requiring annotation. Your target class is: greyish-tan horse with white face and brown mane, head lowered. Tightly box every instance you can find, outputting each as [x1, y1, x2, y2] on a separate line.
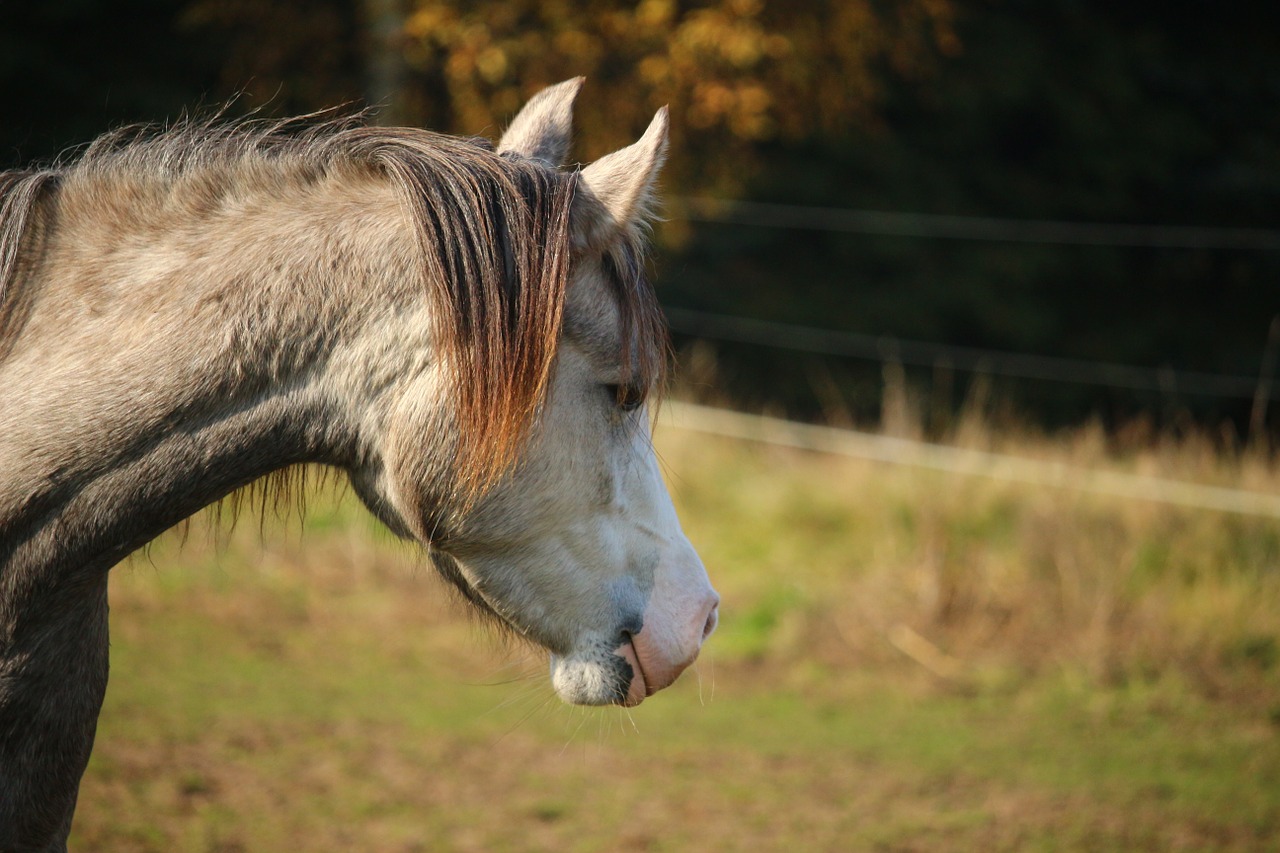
[0, 78, 719, 850]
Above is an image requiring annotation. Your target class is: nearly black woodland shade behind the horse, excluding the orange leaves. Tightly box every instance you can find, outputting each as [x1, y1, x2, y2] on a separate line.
[0, 0, 1280, 441]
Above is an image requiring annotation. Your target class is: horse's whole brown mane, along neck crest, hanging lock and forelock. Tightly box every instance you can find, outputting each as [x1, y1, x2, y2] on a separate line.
[0, 114, 667, 502]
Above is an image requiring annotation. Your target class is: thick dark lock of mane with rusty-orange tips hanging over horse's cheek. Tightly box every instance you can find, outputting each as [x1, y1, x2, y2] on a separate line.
[370, 129, 575, 501]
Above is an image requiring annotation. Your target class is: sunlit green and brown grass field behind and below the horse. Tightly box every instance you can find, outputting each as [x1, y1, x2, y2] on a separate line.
[72, 409, 1280, 853]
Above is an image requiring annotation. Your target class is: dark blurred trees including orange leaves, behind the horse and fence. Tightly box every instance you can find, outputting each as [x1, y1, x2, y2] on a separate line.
[0, 0, 1280, 420]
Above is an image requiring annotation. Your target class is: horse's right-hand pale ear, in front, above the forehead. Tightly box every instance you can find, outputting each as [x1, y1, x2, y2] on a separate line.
[572, 106, 668, 248]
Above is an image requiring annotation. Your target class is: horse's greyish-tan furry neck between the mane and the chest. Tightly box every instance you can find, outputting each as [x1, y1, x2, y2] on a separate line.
[0, 163, 428, 581]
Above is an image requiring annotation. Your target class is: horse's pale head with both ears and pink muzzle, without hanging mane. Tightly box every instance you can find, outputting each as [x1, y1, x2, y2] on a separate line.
[357, 79, 719, 706]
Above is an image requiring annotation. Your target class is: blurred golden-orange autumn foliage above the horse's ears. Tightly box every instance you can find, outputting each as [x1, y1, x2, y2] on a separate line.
[406, 0, 956, 191]
